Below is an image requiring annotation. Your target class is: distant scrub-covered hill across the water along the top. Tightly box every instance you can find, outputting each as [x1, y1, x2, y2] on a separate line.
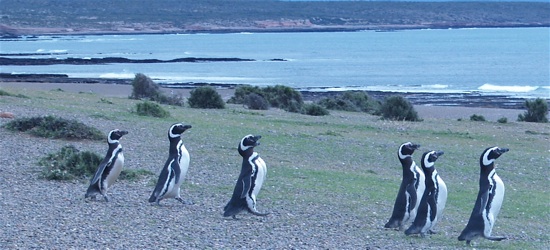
[0, 0, 550, 36]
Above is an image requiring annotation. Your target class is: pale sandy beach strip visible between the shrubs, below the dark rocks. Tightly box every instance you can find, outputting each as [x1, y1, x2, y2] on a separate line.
[0, 82, 525, 121]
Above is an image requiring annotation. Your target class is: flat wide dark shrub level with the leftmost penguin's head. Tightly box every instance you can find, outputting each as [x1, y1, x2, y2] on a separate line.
[4, 116, 105, 140]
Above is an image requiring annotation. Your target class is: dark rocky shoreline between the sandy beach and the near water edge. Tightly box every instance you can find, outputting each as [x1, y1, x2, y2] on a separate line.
[0, 73, 536, 109]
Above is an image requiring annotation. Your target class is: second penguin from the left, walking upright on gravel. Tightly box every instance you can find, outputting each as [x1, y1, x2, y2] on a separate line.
[149, 123, 191, 206]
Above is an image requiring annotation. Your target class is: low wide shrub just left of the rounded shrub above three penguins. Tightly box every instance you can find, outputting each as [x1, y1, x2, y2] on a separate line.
[317, 91, 380, 114]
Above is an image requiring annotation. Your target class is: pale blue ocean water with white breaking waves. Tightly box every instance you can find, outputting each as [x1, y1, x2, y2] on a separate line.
[0, 28, 550, 98]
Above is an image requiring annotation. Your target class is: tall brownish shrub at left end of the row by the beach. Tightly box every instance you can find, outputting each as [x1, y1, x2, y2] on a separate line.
[130, 73, 184, 106]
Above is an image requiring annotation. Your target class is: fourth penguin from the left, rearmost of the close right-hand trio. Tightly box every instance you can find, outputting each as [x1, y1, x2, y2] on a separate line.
[384, 142, 426, 230]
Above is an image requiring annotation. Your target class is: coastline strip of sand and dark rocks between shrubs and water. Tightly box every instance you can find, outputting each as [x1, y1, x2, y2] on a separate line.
[0, 78, 525, 121]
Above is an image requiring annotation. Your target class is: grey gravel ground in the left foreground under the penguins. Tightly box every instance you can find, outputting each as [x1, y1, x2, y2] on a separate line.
[0, 83, 544, 249]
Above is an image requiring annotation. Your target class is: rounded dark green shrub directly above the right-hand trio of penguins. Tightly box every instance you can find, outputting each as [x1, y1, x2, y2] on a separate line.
[379, 95, 420, 121]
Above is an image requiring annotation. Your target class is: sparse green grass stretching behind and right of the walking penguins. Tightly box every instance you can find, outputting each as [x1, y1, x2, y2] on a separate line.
[0, 86, 550, 249]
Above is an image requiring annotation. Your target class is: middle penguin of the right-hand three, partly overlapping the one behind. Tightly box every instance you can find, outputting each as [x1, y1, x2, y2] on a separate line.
[405, 151, 447, 237]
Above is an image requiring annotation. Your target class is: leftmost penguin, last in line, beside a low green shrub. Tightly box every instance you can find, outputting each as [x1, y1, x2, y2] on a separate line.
[84, 129, 128, 201]
